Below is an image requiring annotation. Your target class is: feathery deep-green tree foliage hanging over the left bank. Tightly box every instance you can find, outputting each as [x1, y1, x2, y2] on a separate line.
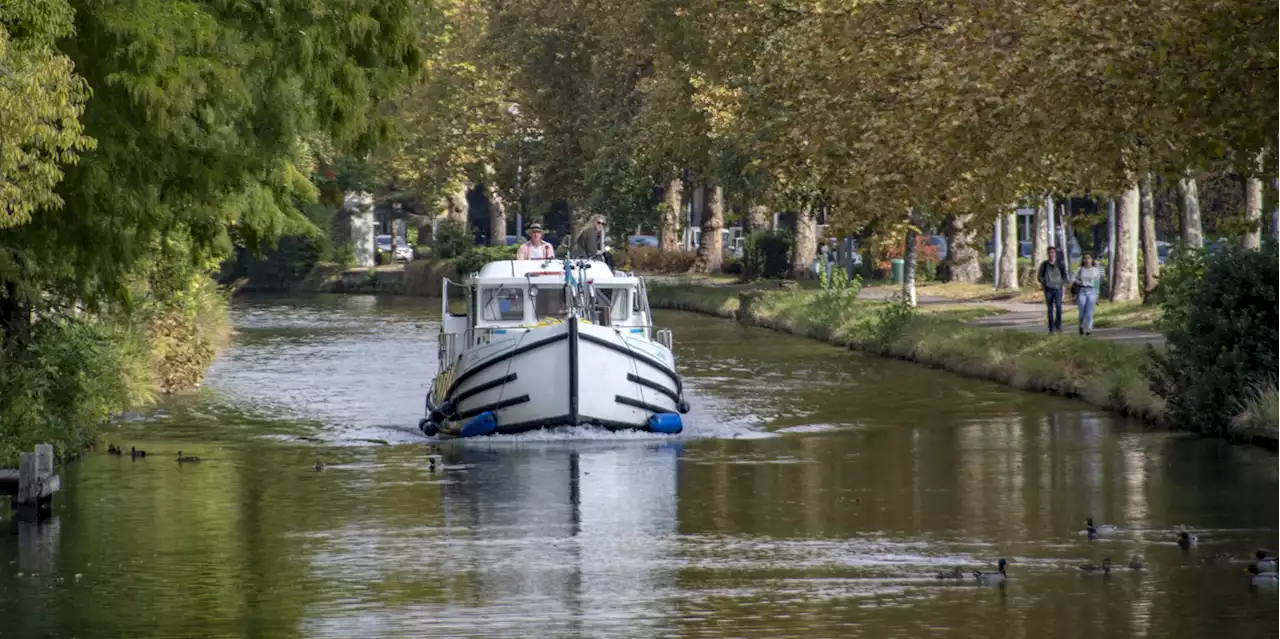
[0, 0, 420, 317]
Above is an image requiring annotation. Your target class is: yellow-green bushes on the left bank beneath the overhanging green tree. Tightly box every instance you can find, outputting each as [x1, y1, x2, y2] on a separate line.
[0, 275, 230, 467]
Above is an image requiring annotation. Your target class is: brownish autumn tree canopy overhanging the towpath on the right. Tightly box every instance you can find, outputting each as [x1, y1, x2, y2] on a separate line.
[373, 0, 1280, 245]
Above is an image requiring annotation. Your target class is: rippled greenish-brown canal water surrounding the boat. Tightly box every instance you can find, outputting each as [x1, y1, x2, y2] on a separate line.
[0, 297, 1280, 639]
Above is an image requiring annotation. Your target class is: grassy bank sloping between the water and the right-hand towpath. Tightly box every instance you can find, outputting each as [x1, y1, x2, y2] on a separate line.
[649, 283, 1166, 423]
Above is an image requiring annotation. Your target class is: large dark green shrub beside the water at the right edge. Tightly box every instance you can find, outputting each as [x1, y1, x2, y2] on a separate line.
[1148, 247, 1280, 434]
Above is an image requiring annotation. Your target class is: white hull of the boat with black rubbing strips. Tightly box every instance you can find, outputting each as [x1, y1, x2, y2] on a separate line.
[422, 321, 689, 437]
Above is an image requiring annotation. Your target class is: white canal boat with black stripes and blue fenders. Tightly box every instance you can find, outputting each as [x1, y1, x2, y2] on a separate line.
[419, 260, 689, 437]
